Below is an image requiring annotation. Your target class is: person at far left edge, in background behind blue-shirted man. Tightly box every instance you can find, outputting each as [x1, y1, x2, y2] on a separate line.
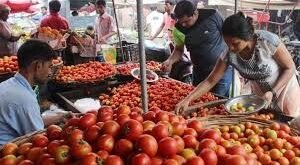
[0, 4, 24, 58]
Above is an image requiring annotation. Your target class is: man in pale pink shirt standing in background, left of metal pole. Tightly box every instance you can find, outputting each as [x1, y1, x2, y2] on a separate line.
[95, 0, 116, 44]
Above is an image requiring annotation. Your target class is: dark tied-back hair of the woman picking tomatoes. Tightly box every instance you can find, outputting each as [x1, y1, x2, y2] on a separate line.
[222, 12, 254, 40]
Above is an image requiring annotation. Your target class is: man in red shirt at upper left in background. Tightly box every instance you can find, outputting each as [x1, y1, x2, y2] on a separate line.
[41, 0, 69, 30]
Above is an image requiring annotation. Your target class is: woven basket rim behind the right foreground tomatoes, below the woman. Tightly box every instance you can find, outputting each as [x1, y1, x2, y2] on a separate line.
[197, 115, 300, 136]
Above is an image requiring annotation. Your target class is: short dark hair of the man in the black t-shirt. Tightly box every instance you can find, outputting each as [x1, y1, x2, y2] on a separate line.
[174, 0, 197, 19]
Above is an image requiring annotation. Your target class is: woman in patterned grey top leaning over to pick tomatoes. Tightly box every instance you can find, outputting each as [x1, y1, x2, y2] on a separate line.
[175, 13, 300, 117]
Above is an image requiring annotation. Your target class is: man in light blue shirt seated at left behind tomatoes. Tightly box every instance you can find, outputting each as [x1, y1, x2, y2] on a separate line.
[0, 40, 70, 146]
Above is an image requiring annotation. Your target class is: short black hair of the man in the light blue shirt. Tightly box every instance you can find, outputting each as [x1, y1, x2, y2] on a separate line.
[17, 40, 56, 69]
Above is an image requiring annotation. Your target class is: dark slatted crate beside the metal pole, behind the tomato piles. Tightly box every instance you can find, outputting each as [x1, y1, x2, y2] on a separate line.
[117, 41, 139, 63]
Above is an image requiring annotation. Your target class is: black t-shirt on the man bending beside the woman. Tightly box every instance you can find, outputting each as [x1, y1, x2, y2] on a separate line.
[175, 9, 227, 74]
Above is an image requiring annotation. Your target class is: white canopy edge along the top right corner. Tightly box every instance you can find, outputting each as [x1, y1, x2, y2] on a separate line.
[208, 0, 300, 10]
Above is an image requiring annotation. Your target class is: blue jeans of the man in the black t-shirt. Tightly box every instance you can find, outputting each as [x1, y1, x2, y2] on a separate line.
[193, 66, 232, 97]
